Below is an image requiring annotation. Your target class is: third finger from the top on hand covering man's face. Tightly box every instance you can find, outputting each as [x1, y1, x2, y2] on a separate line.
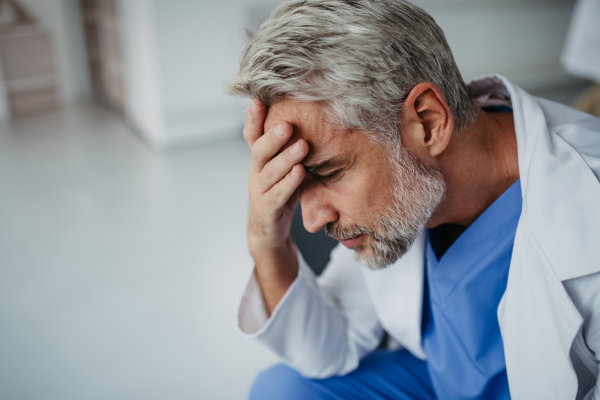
[256, 140, 308, 193]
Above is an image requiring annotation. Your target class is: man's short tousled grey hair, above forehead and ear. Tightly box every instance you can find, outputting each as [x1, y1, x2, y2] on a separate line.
[229, 0, 477, 146]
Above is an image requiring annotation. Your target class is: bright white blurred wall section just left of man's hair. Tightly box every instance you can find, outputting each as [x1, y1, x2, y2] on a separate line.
[152, 0, 253, 146]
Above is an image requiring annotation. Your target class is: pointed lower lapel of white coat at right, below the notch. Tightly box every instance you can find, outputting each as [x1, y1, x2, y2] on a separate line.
[498, 222, 582, 400]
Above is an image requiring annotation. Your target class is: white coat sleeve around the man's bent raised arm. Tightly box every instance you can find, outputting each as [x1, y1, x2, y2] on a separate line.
[238, 246, 383, 378]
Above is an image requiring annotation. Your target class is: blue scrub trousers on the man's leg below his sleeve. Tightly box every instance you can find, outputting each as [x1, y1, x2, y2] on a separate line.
[249, 350, 435, 400]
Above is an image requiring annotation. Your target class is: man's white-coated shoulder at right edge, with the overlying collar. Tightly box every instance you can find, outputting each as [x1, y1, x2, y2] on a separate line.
[513, 88, 600, 281]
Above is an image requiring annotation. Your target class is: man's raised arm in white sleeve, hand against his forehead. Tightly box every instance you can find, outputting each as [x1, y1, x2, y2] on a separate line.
[238, 100, 382, 378]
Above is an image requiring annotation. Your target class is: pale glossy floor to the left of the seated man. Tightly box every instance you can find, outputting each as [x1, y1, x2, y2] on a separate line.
[0, 104, 275, 400]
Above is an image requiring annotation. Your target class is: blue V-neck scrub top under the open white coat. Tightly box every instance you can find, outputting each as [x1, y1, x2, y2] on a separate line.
[423, 181, 522, 400]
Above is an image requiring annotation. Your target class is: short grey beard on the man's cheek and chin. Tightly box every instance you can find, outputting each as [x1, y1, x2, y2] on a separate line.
[324, 145, 445, 270]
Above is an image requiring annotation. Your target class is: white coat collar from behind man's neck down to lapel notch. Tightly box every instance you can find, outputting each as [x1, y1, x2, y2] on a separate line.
[469, 75, 600, 281]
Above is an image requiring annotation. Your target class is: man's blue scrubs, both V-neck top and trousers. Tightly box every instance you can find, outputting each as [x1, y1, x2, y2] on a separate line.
[250, 181, 522, 400]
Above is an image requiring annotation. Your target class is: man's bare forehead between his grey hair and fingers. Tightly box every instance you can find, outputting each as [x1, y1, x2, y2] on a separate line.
[265, 100, 350, 162]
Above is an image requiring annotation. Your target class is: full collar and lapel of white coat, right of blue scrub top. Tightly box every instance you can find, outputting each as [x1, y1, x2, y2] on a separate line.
[496, 77, 600, 399]
